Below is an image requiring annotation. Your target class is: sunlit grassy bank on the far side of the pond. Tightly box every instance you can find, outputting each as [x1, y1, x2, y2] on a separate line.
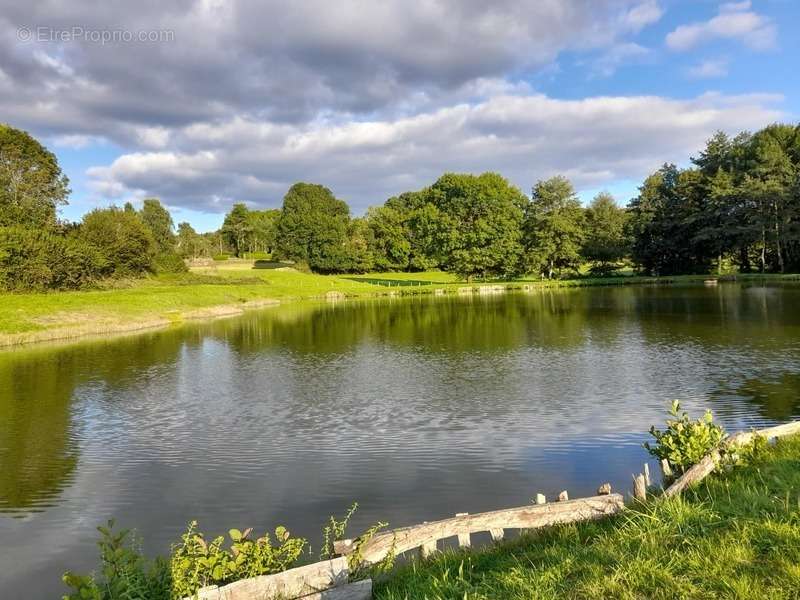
[0, 261, 796, 346]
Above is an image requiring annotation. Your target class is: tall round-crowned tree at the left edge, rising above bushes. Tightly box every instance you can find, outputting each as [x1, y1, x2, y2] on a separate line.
[0, 125, 70, 228]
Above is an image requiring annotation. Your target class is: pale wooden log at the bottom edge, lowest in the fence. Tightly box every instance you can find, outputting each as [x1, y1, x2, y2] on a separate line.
[184, 556, 348, 600]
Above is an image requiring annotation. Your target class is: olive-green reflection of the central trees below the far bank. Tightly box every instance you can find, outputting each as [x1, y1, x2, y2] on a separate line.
[215, 290, 624, 354]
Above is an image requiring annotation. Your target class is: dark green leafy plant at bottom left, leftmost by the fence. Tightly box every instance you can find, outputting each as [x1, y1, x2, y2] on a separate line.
[63, 520, 171, 600]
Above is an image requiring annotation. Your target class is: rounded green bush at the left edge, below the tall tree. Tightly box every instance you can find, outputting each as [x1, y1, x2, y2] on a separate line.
[0, 226, 108, 291]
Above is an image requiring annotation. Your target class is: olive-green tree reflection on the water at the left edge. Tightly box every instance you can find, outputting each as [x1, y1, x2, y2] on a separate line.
[0, 332, 185, 512]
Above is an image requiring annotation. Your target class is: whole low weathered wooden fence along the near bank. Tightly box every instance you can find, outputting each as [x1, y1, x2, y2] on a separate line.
[184, 421, 800, 600]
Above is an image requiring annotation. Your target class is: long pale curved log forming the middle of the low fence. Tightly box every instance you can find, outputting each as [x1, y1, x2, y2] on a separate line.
[350, 494, 624, 563]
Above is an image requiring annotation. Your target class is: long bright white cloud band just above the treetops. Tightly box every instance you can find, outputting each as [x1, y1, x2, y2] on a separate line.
[89, 94, 781, 212]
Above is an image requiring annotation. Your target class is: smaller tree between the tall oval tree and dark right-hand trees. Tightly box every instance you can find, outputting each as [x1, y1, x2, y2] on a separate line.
[582, 192, 628, 274]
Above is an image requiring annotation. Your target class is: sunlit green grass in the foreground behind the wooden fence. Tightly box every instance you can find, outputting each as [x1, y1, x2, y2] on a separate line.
[375, 436, 800, 600]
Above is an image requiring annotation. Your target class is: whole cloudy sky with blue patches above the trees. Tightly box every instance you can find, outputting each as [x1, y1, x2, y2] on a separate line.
[0, 0, 800, 231]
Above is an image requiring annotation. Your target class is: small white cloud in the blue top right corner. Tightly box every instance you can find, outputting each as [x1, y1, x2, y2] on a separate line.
[666, 2, 777, 51]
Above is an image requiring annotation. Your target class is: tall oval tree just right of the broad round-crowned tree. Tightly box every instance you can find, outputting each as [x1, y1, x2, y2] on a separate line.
[524, 176, 584, 278]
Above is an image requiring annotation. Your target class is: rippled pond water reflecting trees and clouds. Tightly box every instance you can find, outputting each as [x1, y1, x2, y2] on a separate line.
[0, 283, 800, 598]
